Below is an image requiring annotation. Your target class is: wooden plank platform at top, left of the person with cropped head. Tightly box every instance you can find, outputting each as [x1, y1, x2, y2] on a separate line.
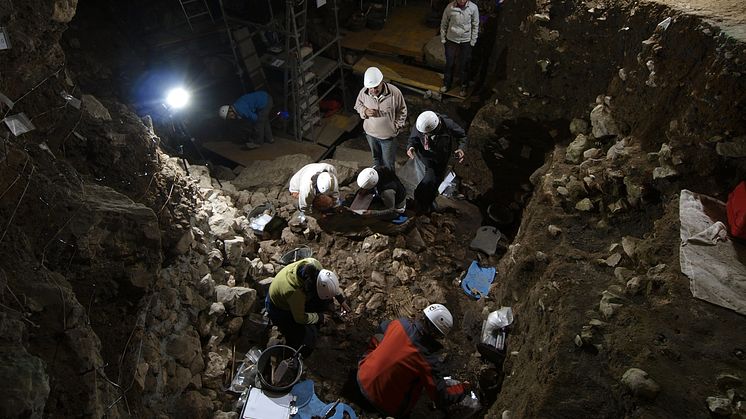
[341, 2, 438, 62]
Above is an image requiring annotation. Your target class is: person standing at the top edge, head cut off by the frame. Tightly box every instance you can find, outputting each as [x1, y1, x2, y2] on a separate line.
[440, 0, 479, 96]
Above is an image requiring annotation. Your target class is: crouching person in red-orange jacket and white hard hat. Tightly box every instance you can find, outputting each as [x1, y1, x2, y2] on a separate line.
[356, 304, 470, 418]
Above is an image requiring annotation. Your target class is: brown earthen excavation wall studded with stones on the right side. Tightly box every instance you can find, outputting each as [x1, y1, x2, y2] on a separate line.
[461, 1, 746, 418]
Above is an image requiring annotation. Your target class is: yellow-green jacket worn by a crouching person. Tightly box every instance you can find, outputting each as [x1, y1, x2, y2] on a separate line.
[269, 258, 321, 324]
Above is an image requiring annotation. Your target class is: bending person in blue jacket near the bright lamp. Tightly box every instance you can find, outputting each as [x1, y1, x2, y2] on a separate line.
[218, 90, 274, 149]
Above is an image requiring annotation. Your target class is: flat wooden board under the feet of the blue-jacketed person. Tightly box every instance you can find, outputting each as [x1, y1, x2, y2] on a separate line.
[202, 134, 326, 166]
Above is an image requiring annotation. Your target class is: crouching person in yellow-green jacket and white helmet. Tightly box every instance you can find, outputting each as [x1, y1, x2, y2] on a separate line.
[264, 258, 350, 356]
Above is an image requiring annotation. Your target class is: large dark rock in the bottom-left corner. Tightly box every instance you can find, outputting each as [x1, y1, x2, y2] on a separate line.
[0, 345, 49, 419]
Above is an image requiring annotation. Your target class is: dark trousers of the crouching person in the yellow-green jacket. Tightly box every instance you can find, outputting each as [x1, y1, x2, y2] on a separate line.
[264, 294, 328, 357]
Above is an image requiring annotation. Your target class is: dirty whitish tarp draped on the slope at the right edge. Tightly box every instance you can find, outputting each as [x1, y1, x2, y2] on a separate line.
[679, 189, 746, 314]
